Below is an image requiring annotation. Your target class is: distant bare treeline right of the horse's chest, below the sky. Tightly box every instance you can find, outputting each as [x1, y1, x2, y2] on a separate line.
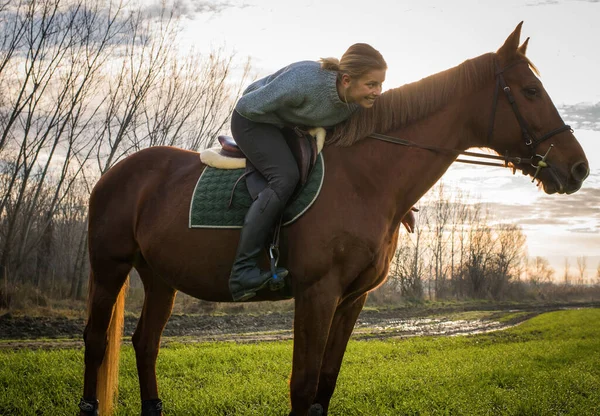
[378, 183, 600, 300]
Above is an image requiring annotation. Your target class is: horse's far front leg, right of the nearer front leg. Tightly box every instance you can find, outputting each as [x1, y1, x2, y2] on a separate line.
[311, 293, 367, 416]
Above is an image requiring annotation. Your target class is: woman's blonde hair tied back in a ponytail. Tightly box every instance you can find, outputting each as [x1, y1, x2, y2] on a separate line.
[319, 43, 387, 78]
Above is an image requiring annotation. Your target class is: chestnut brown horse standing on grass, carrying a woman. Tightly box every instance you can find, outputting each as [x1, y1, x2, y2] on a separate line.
[80, 24, 589, 415]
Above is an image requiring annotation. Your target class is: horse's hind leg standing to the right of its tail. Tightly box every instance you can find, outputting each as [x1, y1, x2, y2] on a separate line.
[132, 260, 176, 416]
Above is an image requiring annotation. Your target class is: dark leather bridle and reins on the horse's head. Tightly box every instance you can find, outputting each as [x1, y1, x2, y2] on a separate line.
[368, 55, 573, 182]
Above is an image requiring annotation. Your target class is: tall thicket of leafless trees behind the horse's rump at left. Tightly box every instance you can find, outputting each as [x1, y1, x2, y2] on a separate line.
[0, 0, 248, 298]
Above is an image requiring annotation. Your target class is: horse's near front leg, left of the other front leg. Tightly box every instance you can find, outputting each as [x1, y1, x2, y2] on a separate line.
[290, 276, 339, 416]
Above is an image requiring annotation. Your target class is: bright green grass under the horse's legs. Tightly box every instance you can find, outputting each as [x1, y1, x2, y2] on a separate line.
[0, 309, 600, 416]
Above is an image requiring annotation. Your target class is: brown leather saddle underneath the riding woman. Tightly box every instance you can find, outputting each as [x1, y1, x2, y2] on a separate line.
[218, 127, 318, 198]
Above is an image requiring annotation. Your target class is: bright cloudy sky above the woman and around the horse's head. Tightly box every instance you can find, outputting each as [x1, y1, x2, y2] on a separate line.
[164, 0, 600, 277]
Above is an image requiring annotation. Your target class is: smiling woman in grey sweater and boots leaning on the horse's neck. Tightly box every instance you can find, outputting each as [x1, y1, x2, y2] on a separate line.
[229, 43, 387, 302]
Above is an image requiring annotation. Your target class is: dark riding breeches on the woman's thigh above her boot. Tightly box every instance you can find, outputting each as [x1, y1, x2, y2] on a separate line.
[231, 111, 300, 202]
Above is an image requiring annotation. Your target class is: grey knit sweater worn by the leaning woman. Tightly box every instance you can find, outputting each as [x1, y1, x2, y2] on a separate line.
[235, 61, 359, 127]
